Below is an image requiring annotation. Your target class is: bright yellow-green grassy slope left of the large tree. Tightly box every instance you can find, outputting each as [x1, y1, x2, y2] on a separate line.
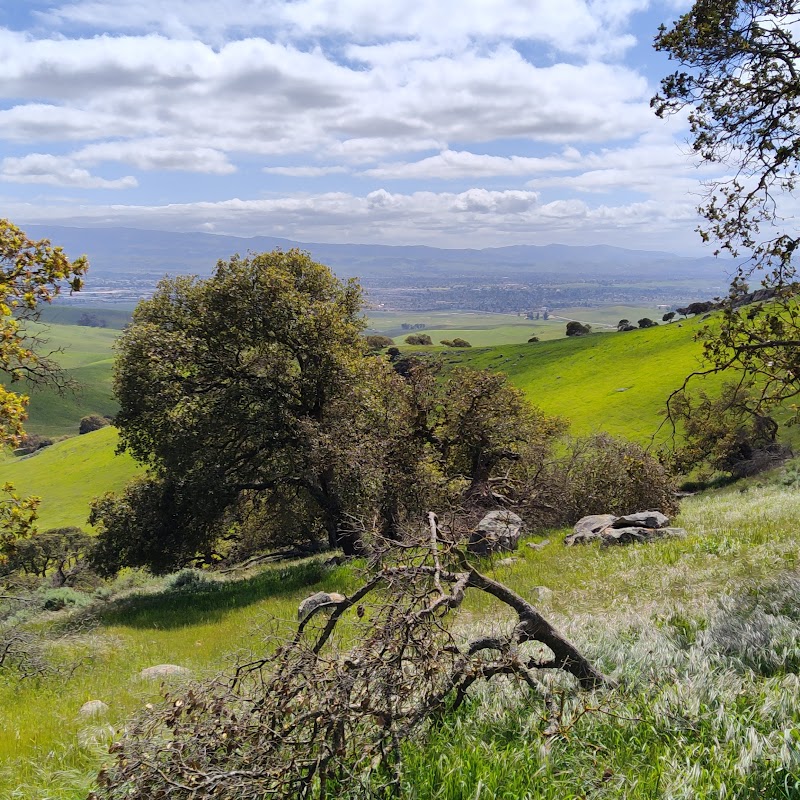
[0, 426, 138, 530]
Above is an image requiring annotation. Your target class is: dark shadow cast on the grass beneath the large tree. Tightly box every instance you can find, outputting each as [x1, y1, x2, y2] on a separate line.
[98, 561, 326, 629]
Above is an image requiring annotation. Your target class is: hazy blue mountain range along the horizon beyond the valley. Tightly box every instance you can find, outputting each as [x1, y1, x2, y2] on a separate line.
[24, 225, 732, 287]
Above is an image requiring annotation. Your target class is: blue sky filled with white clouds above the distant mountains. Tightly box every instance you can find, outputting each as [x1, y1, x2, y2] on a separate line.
[0, 0, 713, 254]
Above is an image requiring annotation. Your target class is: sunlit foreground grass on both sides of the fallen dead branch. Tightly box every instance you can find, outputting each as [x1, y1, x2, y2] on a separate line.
[0, 472, 800, 800]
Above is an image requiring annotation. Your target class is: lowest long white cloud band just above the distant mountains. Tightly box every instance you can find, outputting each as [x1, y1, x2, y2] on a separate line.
[8, 188, 695, 249]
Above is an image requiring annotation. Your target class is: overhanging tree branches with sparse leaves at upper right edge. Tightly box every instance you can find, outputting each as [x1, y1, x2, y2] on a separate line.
[652, 0, 800, 422]
